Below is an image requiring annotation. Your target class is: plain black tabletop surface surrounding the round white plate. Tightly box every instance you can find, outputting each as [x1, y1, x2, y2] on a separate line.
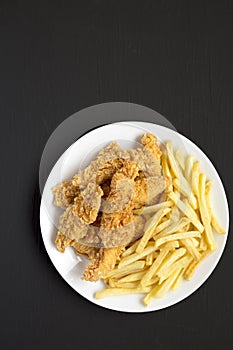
[0, 0, 233, 350]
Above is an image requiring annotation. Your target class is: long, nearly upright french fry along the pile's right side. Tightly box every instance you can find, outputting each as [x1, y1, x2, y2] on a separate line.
[198, 174, 216, 251]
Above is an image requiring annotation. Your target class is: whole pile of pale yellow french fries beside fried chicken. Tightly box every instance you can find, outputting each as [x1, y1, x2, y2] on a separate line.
[95, 141, 225, 306]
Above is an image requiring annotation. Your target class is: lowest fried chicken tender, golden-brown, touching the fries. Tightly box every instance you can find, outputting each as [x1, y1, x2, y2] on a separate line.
[83, 247, 125, 282]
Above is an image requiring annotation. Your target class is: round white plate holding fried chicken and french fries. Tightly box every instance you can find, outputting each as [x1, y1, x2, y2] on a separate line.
[40, 122, 229, 312]
